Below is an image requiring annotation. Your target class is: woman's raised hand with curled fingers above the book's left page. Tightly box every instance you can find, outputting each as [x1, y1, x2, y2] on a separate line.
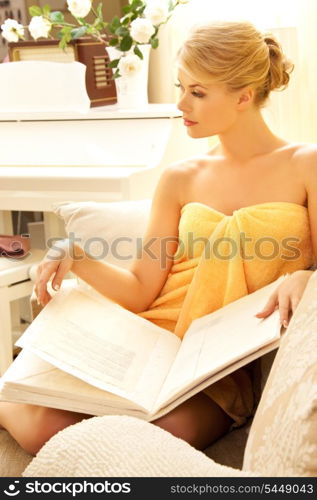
[34, 239, 74, 306]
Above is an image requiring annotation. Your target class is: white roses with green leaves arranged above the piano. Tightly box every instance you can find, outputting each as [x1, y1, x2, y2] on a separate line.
[1, 0, 189, 78]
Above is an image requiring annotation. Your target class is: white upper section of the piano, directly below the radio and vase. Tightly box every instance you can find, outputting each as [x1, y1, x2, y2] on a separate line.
[0, 104, 181, 168]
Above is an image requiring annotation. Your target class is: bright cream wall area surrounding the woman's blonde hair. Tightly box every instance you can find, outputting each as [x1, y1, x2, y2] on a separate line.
[149, 0, 317, 142]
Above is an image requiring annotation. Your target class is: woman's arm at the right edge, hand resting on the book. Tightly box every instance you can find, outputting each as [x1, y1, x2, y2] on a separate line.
[256, 146, 317, 327]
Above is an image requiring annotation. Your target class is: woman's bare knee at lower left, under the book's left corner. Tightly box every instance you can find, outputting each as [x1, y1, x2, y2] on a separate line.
[0, 402, 92, 455]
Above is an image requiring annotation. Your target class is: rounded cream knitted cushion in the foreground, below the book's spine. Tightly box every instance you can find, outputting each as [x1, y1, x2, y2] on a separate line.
[23, 416, 255, 477]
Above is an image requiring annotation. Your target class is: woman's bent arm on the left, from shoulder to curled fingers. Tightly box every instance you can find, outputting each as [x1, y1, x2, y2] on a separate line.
[35, 165, 182, 312]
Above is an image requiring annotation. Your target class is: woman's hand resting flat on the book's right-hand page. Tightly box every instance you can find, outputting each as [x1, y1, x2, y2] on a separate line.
[255, 270, 313, 328]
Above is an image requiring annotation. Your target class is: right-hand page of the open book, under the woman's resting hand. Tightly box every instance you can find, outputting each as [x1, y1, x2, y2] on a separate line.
[155, 279, 281, 409]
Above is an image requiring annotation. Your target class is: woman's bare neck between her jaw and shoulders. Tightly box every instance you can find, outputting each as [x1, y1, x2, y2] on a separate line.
[218, 108, 287, 163]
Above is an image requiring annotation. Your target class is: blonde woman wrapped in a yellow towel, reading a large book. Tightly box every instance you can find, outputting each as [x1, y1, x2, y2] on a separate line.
[0, 22, 317, 453]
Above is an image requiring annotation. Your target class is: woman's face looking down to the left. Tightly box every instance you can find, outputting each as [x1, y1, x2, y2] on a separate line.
[176, 69, 238, 138]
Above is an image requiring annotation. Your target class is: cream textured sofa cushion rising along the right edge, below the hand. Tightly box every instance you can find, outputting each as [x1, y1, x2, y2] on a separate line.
[243, 271, 317, 477]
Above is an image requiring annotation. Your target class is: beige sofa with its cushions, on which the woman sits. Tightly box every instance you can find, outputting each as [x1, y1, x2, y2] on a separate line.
[0, 200, 317, 477]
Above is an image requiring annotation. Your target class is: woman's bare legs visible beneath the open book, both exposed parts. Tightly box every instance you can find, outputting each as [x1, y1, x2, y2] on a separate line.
[0, 393, 233, 455]
